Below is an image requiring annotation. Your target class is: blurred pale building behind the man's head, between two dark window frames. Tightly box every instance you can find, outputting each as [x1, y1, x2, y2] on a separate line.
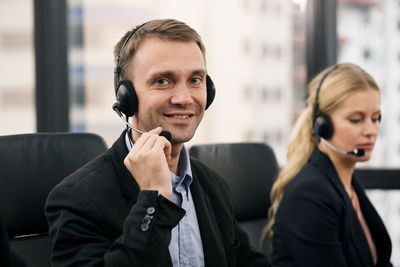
[70, 0, 305, 165]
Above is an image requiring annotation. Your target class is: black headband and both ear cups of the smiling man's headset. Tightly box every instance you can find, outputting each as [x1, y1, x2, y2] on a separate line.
[113, 22, 215, 117]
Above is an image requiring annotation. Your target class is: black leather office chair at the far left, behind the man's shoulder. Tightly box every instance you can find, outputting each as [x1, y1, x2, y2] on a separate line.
[0, 133, 107, 267]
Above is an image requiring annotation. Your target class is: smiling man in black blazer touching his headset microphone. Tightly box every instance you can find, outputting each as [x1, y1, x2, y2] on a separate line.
[46, 19, 269, 267]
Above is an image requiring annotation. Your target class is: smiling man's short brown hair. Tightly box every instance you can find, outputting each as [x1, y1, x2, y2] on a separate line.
[114, 19, 206, 79]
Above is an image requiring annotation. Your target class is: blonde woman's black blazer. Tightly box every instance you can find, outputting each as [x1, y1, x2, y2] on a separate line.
[272, 148, 392, 267]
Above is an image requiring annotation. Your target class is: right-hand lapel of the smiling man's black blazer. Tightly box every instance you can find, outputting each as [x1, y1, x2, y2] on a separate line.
[190, 168, 227, 266]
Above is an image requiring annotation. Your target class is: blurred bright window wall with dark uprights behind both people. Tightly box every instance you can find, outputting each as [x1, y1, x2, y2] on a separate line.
[0, 0, 400, 266]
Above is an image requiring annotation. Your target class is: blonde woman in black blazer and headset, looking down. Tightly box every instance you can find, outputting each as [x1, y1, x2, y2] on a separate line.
[267, 64, 392, 267]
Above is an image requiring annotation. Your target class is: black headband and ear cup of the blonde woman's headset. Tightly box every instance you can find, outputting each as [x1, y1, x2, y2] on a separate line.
[312, 64, 340, 139]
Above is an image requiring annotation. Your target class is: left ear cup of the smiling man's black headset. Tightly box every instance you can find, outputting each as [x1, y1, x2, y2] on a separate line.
[117, 80, 138, 117]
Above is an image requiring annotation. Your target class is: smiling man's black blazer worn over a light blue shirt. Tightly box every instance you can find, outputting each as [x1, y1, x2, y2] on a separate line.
[45, 132, 269, 267]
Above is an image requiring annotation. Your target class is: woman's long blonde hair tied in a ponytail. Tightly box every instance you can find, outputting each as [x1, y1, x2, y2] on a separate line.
[263, 63, 379, 247]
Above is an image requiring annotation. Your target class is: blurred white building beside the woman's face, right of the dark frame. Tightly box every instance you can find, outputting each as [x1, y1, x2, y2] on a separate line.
[338, 0, 400, 167]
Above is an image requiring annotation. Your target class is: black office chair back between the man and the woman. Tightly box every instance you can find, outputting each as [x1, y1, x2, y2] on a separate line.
[189, 143, 279, 248]
